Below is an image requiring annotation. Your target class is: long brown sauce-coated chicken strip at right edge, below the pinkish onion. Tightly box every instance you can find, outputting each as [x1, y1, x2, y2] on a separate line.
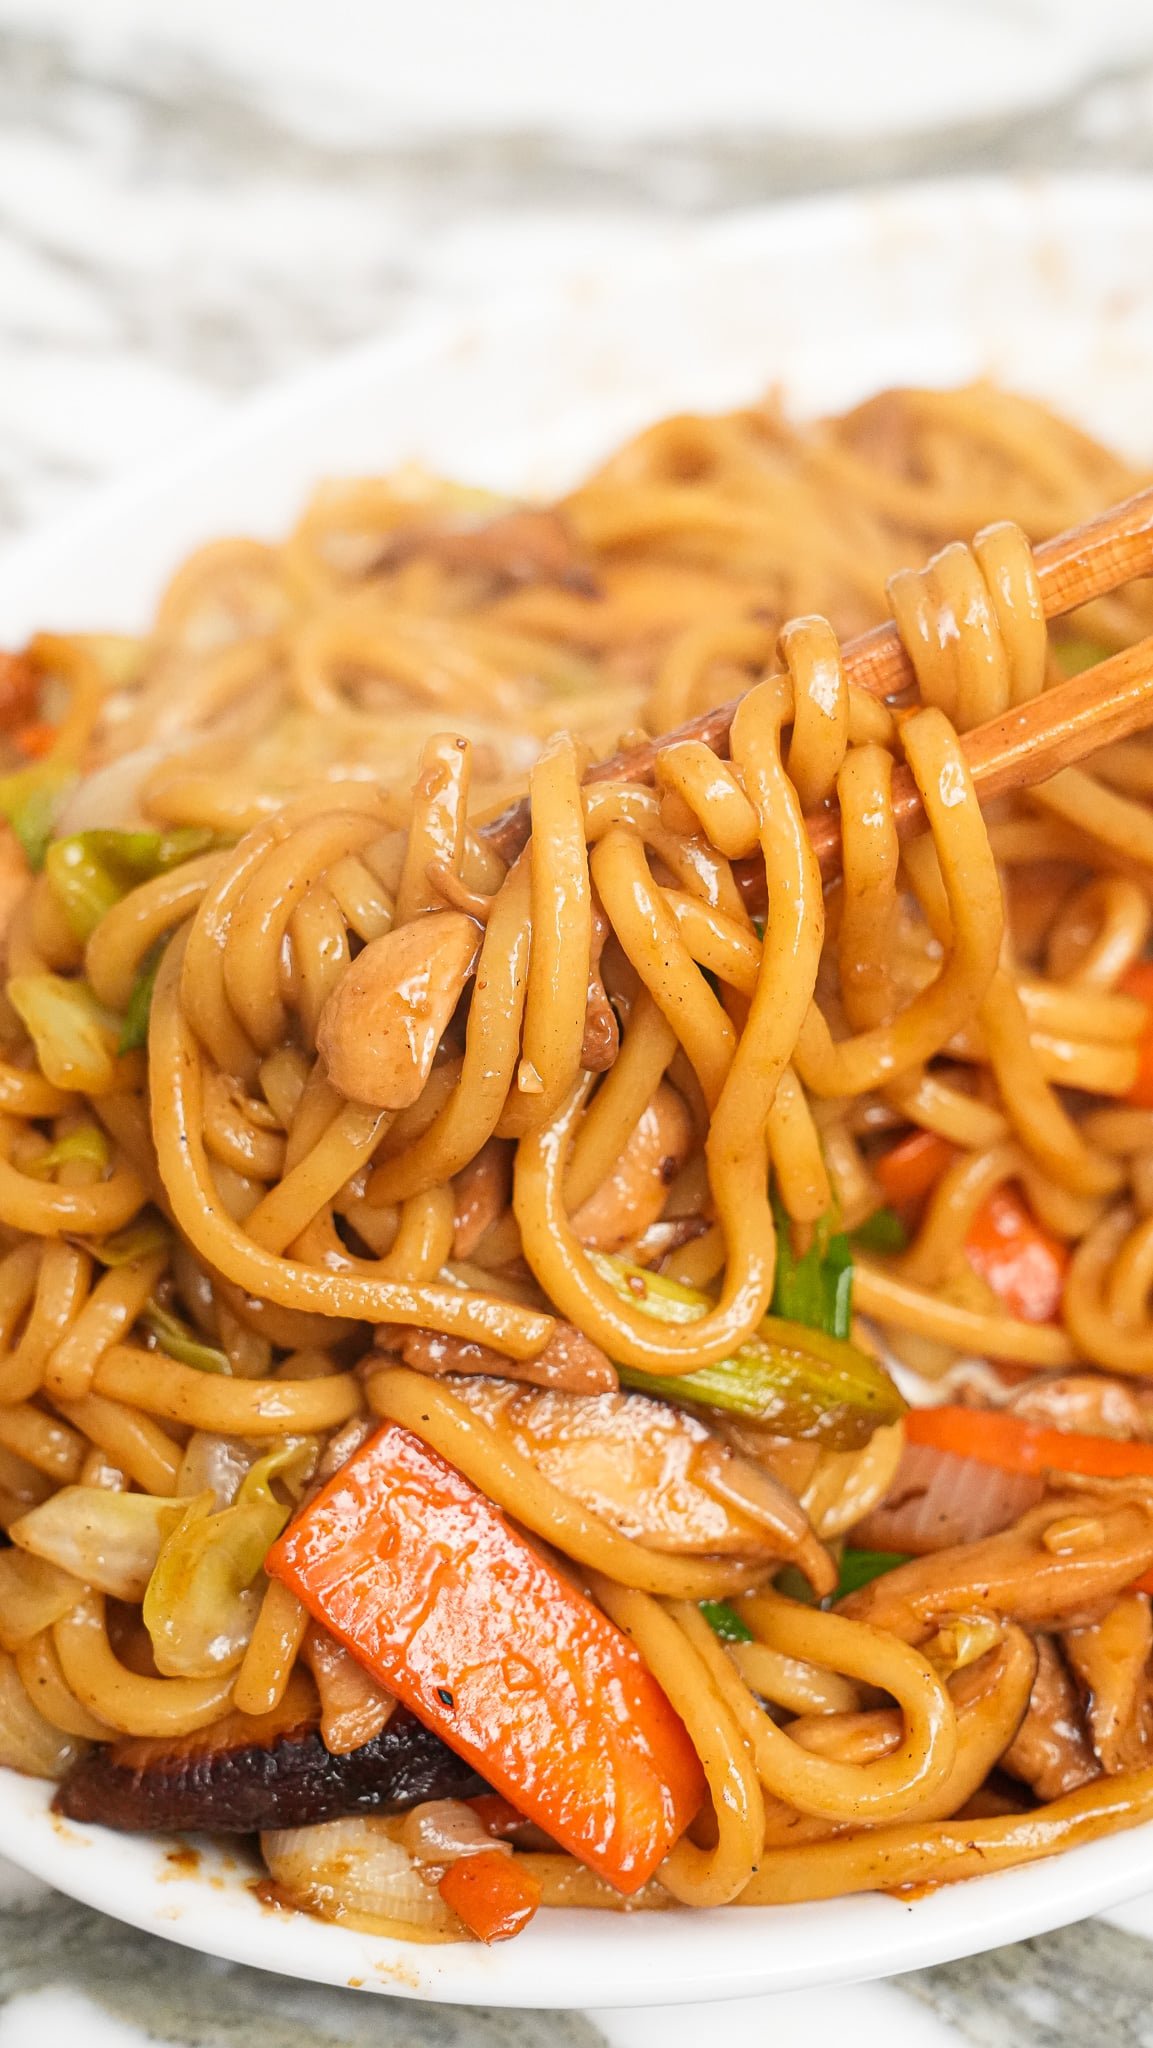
[840, 1489, 1153, 1642]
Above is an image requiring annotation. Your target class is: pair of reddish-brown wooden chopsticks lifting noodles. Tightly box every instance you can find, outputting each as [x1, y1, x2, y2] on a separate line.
[481, 489, 1153, 877]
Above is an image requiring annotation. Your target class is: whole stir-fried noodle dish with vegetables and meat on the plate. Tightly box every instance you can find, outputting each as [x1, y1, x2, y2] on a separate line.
[0, 387, 1153, 1942]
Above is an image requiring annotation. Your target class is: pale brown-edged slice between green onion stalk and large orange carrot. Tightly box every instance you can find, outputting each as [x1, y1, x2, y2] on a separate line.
[451, 1378, 836, 1583]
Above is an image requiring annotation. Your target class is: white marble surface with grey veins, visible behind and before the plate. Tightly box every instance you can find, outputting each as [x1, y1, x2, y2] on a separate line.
[0, 0, 1153, 2048]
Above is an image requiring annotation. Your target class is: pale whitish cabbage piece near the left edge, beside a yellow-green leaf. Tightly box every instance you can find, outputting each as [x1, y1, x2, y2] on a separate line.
[8, 1487, 188, 1599]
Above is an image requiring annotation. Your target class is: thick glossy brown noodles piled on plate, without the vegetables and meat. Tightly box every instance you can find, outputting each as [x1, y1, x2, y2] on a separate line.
[0, 387, 1153, 1923]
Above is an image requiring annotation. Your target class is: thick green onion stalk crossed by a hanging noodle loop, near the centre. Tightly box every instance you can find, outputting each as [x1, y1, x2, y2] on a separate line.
[590, 1251, 907, 1450]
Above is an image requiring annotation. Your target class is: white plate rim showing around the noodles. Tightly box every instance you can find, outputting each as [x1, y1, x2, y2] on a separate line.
[0, 180, 1153, 2007]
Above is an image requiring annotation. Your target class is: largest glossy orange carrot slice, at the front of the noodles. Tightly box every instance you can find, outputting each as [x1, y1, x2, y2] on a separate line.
[266, 1423, 704, 1892]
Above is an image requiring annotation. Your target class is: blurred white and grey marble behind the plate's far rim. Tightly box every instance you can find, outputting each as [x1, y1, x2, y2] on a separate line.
[0, 0, 1153, 541]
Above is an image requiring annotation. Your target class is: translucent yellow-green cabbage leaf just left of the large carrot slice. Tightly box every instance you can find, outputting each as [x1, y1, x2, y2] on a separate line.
[143, 1438, 315, 1677]
